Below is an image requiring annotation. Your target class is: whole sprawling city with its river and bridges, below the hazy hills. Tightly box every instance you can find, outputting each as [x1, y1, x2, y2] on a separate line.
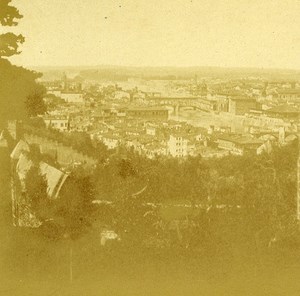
[43, 76, 300, 158]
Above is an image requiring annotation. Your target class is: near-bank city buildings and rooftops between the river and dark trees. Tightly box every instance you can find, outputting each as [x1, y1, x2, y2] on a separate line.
[44, 105, 297, 158]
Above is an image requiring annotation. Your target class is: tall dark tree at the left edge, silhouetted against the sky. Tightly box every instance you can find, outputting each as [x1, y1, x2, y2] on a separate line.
[0, 0, 44, 126]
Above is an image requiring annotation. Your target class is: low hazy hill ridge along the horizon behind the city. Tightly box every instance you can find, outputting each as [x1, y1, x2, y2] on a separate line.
[32, 65, 300, 81]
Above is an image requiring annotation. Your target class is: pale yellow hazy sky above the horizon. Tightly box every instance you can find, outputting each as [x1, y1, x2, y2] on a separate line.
[4, 0, 300, 69]
